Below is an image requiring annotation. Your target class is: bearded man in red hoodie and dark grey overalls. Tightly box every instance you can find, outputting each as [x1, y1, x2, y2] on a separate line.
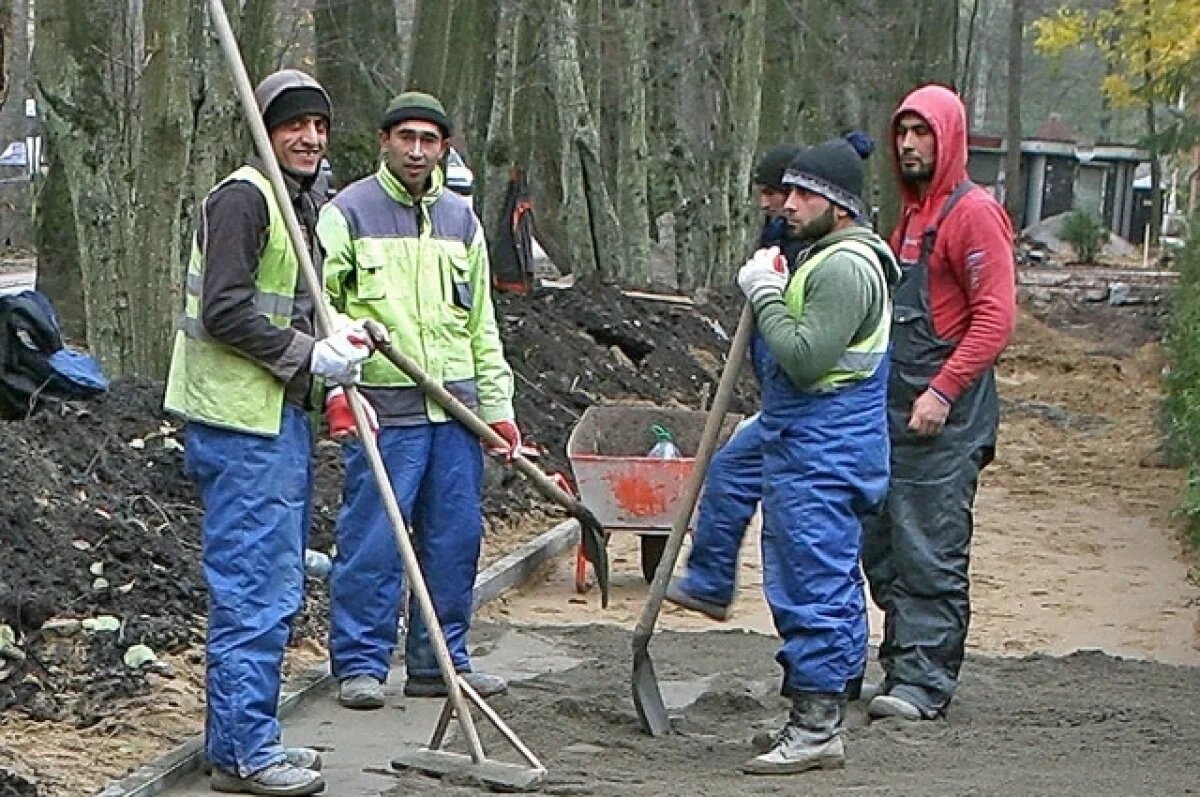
[863, 85, 1016, 720]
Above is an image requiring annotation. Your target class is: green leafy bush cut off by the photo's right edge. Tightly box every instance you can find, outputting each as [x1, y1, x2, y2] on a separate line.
[1164, 210, 1200, 546]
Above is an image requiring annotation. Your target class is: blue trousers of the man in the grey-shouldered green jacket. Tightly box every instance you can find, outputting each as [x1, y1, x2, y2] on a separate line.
[330, 421, 484, 681]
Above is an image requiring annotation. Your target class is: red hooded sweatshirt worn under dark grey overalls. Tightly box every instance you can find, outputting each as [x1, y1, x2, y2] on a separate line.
[892, 85, 1016, 402]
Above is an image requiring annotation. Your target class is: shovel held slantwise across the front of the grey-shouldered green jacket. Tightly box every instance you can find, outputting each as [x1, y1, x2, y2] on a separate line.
[364, 320, 608, 609]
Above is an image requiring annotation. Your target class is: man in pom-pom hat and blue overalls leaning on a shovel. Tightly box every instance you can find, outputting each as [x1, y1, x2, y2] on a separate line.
[724, 139, 900, 774]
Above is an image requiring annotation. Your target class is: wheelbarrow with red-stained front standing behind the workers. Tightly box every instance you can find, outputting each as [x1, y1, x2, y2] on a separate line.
[566, 405, 742, 593]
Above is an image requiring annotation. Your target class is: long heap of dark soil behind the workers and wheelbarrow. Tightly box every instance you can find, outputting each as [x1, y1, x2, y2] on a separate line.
[0, 279, 750, 727]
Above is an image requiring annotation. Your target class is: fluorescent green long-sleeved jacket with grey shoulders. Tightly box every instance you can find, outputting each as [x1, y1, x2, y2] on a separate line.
[317, 164, 514, 425]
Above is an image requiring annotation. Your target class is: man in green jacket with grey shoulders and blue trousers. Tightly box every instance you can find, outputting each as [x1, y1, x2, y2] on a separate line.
[319, 91, 521, 708]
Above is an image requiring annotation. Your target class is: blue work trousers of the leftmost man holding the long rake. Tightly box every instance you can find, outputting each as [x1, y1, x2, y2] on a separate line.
[185, 406, 313, 777]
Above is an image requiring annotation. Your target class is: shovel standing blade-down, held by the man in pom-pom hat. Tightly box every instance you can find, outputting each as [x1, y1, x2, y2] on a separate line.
[632, 302, 754, 736]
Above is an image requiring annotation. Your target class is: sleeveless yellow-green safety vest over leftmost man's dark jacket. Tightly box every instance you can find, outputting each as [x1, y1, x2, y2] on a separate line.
[163, 166, 299, 436]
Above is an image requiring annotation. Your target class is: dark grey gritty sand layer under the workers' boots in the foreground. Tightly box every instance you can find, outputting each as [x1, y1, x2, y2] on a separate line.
[385, 624, 1200, 797]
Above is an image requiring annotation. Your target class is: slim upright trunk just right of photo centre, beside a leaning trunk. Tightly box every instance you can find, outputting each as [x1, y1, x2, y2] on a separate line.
[617, 0, 652, 284]
